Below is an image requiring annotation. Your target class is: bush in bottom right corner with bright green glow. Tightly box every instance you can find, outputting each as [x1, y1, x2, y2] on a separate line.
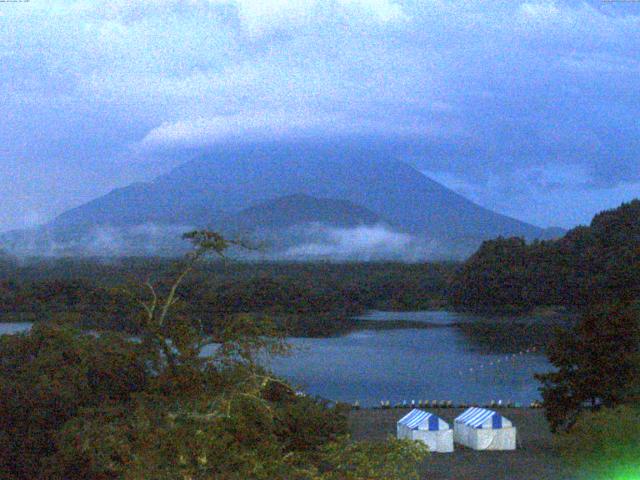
[556, 405, 640, 480]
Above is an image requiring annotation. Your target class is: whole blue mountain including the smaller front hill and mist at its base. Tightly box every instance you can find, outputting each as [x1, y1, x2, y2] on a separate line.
[0, 144, 558, 260]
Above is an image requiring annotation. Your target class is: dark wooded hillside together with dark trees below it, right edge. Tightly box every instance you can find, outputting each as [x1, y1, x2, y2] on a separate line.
[449, 200, 640, 436]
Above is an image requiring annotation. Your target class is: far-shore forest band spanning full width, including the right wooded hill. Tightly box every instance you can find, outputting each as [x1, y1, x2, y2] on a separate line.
[0, 200, 640, 334]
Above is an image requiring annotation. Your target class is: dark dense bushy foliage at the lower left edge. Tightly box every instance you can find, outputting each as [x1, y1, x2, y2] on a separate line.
[0, 324, 149, 478]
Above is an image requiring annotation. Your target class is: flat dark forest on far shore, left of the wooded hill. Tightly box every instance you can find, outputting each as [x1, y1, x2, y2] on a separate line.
[0, 258, 456, 336]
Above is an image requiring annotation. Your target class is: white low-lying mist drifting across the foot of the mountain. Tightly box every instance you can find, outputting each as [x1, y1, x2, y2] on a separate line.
[0, 223, 468, 262]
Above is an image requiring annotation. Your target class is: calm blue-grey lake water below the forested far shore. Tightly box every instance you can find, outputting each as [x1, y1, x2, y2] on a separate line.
[0, 311, 551, 406]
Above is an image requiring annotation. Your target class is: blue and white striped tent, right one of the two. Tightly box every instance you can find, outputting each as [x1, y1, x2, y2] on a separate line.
[453, 407, 516, 450]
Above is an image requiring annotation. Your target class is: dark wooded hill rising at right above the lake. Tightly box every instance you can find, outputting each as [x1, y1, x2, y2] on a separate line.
[449, 200, 640, 312]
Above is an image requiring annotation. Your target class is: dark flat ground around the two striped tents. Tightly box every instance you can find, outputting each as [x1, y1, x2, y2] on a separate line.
[349, 408, 572, 480]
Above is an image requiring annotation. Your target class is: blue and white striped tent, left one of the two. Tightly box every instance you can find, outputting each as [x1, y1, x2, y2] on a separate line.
[397, 409, 453, 452]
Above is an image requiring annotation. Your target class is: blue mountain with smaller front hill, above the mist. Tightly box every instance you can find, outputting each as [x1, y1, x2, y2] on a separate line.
[1, 144, 556, 255]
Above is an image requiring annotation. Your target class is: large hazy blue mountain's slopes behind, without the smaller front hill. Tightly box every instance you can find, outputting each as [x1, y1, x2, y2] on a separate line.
[52, 145, 545, 240]
